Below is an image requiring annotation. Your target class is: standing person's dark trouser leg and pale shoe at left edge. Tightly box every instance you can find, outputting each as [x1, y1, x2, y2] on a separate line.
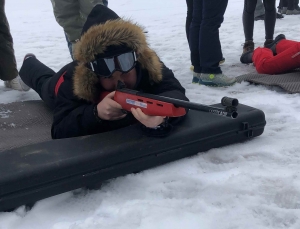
[0, 0, 30, 91]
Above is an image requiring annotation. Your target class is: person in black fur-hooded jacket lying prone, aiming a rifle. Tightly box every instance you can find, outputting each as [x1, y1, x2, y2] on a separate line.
[20, 5, 188, 138]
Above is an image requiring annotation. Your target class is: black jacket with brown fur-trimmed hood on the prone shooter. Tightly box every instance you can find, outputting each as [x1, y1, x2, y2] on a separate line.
[52, 5, 188, 138]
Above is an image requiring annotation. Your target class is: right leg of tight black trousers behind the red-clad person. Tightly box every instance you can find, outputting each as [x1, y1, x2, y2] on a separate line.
[264, 0, 276, 39]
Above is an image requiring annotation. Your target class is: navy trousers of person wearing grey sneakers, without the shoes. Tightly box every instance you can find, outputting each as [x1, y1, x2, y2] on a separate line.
[187, 0, 228, 74]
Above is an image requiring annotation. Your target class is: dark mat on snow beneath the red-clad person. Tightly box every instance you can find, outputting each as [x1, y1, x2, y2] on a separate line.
[236, 69, 300, 93]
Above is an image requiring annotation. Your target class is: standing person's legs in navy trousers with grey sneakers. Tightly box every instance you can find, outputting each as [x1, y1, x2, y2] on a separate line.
[186, 0, 235, 87]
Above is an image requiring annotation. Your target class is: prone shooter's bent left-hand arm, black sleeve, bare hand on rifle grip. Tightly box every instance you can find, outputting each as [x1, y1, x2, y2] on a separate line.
[51, 71, 135, 139]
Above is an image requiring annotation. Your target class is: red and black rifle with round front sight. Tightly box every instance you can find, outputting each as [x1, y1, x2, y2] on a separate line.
[114, 88, 239, 118]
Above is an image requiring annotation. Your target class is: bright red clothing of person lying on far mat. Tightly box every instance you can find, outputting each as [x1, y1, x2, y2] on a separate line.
[252, 39, 300, 74]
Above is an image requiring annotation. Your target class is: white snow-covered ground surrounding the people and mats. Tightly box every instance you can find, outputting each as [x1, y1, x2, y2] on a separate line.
[0, 0, 300, 229]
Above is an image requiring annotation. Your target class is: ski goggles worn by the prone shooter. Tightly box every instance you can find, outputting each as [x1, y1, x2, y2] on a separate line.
[90, 51, 137, 78]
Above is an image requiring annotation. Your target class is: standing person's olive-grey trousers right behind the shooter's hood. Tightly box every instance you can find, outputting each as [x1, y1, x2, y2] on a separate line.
[51, 0, 108, 59]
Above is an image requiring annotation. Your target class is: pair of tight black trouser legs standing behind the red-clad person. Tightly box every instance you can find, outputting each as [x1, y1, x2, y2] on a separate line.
[243, 0, 276, 41]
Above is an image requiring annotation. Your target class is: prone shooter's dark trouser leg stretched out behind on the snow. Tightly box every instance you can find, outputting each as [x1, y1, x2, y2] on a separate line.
[19, 57, 56, 109]
